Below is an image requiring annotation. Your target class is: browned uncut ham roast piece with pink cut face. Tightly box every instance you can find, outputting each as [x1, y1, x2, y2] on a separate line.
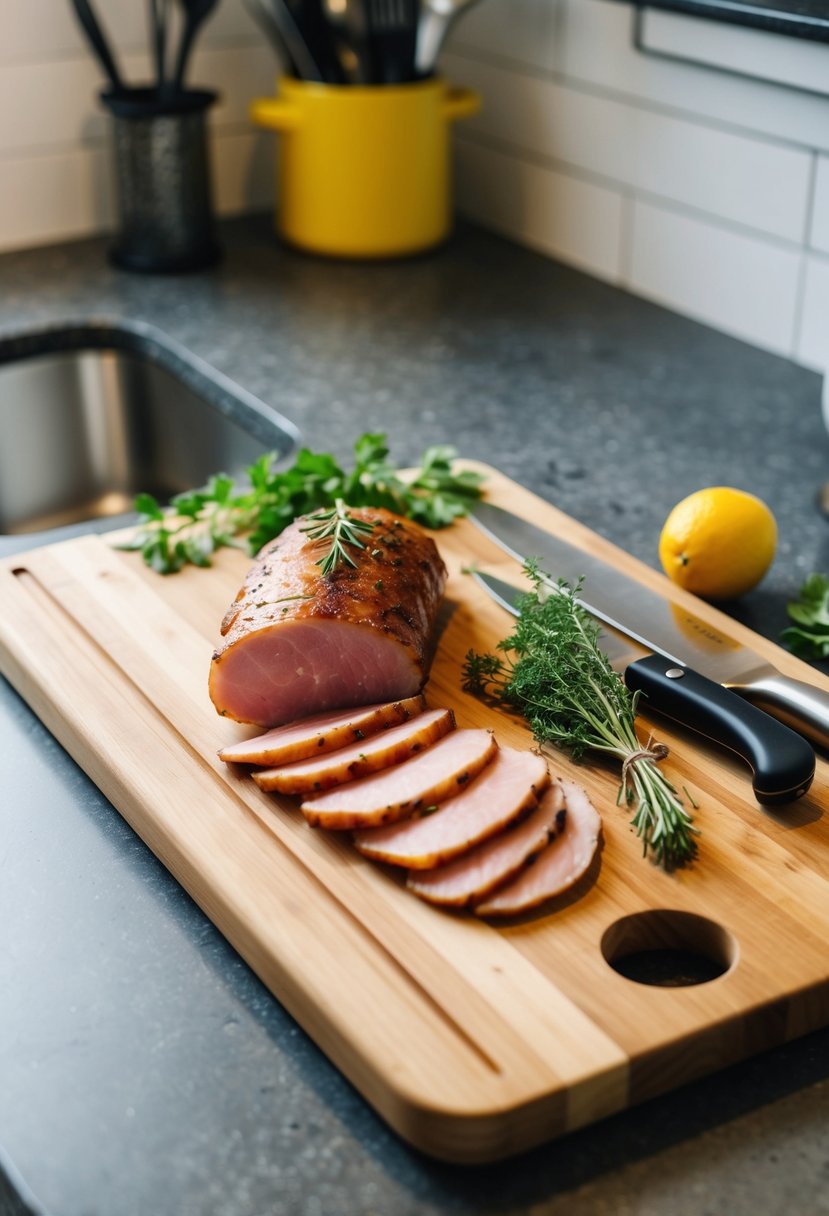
[209, 507, 446, 726]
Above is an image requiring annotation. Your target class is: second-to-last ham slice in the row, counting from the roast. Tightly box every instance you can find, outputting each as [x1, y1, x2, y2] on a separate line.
[406, 786, 566, 907]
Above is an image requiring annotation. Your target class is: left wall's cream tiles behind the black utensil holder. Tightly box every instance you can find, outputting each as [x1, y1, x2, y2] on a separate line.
[0, 0, 278, 249]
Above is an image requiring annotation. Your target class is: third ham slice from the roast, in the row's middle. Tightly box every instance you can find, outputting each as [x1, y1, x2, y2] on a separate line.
[303, 730, 498, 831]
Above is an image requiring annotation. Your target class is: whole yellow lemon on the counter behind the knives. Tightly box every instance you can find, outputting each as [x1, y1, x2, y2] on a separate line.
[659, 485, 777, 599]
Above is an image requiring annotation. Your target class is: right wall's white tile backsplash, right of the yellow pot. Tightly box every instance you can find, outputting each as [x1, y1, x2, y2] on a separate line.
[442, 0, 829, 371]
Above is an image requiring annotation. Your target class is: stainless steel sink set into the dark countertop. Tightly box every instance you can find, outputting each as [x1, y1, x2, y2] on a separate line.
[0, 330, 298, 535]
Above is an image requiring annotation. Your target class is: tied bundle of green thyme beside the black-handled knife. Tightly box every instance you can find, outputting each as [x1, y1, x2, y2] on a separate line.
[463, 562, 697, 871]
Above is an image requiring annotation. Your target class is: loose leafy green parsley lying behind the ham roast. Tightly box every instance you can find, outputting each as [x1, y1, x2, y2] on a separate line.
[123, 432, 481, 574]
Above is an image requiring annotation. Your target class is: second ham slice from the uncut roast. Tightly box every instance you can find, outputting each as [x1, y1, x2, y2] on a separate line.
[253, 709, 455, 794]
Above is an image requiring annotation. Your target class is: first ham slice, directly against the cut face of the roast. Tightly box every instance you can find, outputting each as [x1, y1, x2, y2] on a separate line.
[219, 696, 425, 765]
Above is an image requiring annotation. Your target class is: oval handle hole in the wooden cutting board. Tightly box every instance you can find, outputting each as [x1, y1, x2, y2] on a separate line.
[602, 908, 739, 987]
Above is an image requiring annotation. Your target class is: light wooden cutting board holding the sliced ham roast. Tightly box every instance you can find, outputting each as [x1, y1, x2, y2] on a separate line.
[0, 466, 829, 1161]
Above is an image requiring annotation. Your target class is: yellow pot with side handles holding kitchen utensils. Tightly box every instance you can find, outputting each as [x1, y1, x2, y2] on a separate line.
[250, 77, 480, 258]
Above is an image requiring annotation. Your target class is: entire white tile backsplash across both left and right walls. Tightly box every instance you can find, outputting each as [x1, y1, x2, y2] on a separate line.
[0, 0, 829, 393]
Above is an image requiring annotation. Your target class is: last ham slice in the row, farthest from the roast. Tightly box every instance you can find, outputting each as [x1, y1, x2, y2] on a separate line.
[475, 781, 602, 916]
